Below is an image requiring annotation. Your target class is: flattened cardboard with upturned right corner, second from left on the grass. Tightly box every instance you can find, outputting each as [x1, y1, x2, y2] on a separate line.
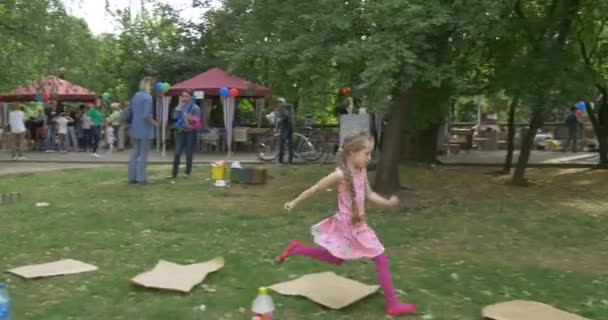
[131, 257, 224, 293]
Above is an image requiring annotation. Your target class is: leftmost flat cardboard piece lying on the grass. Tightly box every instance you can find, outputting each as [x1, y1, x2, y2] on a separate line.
[6, 259, 97, 279]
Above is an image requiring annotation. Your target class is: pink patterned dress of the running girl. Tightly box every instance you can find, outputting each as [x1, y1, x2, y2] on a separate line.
[311, 170, 384, 260]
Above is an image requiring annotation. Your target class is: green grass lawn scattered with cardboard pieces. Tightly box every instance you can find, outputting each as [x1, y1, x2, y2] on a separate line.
[0, 166, 608, 320]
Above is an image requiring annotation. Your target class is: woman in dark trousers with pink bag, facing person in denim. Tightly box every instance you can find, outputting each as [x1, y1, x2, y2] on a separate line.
[171, 90, 202, 179]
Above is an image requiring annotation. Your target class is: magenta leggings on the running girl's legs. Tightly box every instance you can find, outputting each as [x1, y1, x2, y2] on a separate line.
[292, 245, 398, 305]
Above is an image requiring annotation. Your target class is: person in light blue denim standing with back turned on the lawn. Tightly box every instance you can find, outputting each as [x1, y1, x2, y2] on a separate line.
[126, 77, 157, 184]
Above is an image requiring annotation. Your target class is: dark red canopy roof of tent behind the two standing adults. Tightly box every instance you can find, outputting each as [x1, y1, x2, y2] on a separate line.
[167, 68, 270, 98]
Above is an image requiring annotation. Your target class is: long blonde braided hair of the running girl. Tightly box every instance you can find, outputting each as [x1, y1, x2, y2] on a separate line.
[337, 131, 372, 224]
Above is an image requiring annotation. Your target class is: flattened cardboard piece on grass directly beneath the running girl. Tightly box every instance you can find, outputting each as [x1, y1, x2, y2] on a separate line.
[269, 272, 379, 309]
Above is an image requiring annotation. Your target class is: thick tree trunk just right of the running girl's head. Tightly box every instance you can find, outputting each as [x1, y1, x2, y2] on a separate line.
[375, 92, 408, 195]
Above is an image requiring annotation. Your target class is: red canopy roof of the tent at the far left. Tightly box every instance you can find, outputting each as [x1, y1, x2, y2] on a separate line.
[0, 76, 97, 102]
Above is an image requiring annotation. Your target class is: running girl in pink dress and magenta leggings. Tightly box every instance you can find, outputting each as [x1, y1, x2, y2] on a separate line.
[279, 132, 416, 316]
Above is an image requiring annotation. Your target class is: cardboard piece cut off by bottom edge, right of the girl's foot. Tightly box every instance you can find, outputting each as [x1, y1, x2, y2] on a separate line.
[482, 300, 591, 320]
